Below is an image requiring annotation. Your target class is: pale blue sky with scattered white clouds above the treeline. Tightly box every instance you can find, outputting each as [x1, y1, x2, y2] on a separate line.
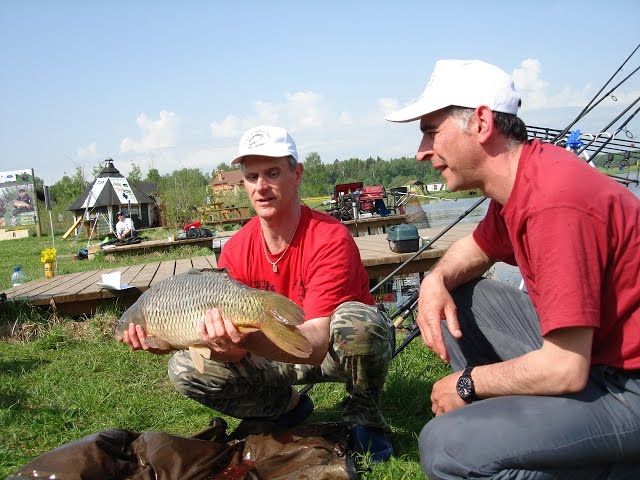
[0, 0, 640, 185]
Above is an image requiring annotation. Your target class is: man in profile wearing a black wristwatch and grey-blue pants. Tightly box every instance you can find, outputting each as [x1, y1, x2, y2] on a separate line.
[386, 60, 640, 480]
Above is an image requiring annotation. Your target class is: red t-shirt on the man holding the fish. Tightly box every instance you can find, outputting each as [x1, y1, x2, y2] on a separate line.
[218, 206, 374, 319]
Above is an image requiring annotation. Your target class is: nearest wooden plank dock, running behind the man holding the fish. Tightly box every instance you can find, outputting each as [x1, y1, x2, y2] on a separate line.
[4, 224, 476, 315]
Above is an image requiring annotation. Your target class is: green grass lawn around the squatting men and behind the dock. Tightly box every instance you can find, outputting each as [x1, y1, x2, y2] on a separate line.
[0, 231, 449, 480]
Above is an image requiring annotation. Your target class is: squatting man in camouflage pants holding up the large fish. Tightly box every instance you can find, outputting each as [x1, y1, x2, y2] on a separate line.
[123, 126, 394, 462]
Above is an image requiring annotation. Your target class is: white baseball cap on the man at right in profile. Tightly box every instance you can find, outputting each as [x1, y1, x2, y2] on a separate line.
[384, 60, 521, 122]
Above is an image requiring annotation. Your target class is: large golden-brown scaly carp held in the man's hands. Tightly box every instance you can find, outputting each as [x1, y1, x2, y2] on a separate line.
[115, 269, 311, 373]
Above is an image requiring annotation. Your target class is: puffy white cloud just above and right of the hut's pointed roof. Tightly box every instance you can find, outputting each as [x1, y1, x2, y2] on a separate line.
[120, 110, 180, 153]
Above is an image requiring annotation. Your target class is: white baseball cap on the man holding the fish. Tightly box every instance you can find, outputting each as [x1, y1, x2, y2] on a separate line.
[231, 125, 298, 165]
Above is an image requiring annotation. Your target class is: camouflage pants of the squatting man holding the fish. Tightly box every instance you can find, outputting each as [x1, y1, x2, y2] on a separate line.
[169, 302, 394, 429]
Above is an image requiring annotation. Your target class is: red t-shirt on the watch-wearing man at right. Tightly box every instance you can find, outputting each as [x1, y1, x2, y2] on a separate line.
[473, 140, 640, 370]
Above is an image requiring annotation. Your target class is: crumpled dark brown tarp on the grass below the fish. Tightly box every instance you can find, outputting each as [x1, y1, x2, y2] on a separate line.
[7, 419, 357, 480]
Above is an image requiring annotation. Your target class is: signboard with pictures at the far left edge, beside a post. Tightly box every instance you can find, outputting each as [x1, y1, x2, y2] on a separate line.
[0, 169, 39, 228]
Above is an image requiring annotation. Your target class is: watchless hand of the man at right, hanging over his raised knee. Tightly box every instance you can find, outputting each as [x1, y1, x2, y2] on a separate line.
[417, 274, 462, 362]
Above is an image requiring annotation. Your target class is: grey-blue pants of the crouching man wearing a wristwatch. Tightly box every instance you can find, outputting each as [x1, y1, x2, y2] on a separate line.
[419, 279, 640, 480]
